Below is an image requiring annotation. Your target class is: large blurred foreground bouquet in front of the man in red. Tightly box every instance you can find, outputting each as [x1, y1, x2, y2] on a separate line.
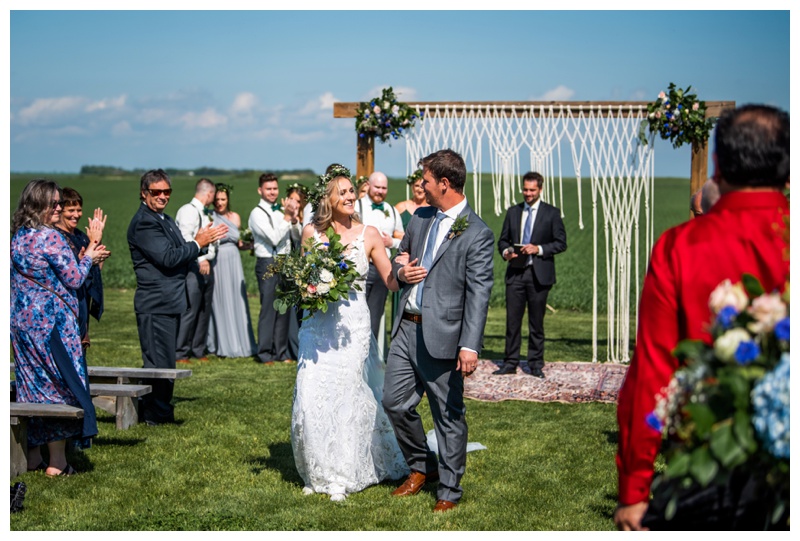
[647, 275, 789, 522]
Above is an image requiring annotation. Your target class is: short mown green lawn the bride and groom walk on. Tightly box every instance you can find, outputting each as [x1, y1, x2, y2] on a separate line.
[10, 290, 616, 531]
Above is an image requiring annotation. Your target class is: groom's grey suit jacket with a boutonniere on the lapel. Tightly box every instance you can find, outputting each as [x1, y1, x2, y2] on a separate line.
[392, 205, 494, 359]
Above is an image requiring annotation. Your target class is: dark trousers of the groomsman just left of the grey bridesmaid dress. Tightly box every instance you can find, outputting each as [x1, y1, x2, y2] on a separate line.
[175, 263, 214, 360]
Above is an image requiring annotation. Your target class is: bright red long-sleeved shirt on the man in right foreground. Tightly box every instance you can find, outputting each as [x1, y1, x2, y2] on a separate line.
[616, 191, 789, 505]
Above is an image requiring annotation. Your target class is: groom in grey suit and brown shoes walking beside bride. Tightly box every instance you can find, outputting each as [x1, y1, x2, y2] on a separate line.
[383, 149, 494, 512]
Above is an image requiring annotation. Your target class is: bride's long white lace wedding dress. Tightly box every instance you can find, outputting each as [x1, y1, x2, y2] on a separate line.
[292, 228, 409, 500]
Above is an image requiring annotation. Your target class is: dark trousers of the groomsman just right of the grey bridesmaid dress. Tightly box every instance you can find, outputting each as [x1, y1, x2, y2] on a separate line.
[256, 257, 292, 363]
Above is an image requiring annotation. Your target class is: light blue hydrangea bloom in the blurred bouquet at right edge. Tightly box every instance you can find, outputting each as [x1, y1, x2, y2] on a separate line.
[751, 353, 790, 458]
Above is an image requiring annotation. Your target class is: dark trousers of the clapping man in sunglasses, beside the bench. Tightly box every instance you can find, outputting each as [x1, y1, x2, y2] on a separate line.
[136, 313, 181, 423]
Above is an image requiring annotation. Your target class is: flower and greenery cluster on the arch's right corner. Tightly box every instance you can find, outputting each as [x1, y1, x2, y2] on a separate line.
[639, 83, 717, 148]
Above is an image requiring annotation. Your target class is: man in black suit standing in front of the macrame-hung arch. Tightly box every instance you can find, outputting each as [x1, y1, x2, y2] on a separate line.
[494, 172, 567, 378]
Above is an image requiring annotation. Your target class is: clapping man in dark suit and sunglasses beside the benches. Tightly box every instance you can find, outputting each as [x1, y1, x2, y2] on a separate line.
[128, 169, 228, 426]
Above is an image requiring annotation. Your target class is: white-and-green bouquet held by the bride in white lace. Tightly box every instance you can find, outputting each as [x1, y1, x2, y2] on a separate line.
[265, 227, 361, 319]
